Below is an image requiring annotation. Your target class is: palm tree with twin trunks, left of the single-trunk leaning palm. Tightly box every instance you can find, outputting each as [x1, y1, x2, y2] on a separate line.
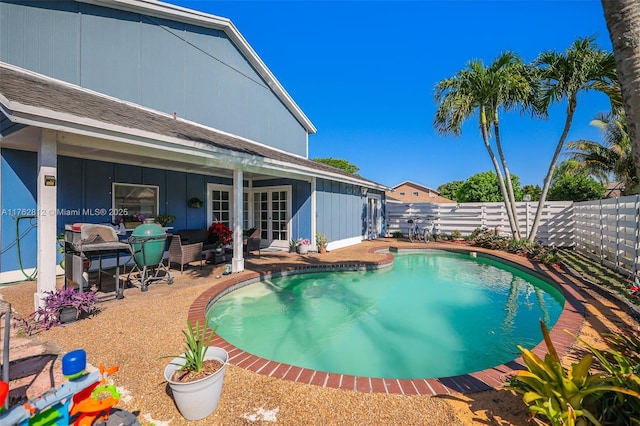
[434, 52, 533, 238]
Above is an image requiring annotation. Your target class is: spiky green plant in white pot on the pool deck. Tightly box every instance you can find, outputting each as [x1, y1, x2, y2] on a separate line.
[164, 321, 229, 420]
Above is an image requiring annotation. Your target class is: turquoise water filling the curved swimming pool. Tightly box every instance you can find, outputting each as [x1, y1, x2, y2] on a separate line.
[207, 251, 564, 379]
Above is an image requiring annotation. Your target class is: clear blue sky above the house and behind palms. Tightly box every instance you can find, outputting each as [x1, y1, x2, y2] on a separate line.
[170, 0, 612, 188]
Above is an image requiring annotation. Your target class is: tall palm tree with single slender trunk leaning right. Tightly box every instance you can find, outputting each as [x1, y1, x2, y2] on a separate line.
[529, 37, 616, 242]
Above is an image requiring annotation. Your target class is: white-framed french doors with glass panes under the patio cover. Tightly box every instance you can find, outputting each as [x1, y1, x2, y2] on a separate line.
[253, 187, 291, 244]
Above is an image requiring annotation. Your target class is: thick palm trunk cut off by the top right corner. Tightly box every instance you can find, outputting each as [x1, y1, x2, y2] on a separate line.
[602, 0, 640, 191]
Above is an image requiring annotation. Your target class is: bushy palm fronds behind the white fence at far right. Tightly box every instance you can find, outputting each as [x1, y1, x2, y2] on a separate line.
[567, 113, 638, 195]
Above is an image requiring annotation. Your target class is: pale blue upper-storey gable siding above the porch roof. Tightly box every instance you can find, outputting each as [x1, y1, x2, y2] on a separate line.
[0, 0, 307, 156]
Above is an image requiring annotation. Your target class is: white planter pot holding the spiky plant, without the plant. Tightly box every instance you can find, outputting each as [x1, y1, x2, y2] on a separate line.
[164, 346, 229, 420]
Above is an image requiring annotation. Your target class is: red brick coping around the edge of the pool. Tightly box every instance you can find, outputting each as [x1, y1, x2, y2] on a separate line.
[188, 244, 585, 396]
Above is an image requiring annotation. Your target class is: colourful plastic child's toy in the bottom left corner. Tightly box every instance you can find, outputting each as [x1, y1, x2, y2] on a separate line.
[0, 349, 139, 426]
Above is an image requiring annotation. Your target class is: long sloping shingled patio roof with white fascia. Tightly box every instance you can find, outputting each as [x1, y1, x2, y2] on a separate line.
[0, 62, 388, 190]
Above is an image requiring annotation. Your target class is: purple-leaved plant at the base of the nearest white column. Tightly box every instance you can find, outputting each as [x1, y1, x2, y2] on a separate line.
[31, 288, 98, 330]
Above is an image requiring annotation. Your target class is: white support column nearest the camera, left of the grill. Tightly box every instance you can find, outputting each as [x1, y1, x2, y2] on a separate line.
[34, 129, 58, 309]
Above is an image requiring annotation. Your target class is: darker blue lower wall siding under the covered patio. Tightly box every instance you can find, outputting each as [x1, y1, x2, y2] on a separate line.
[0, 148, 311, 272]
